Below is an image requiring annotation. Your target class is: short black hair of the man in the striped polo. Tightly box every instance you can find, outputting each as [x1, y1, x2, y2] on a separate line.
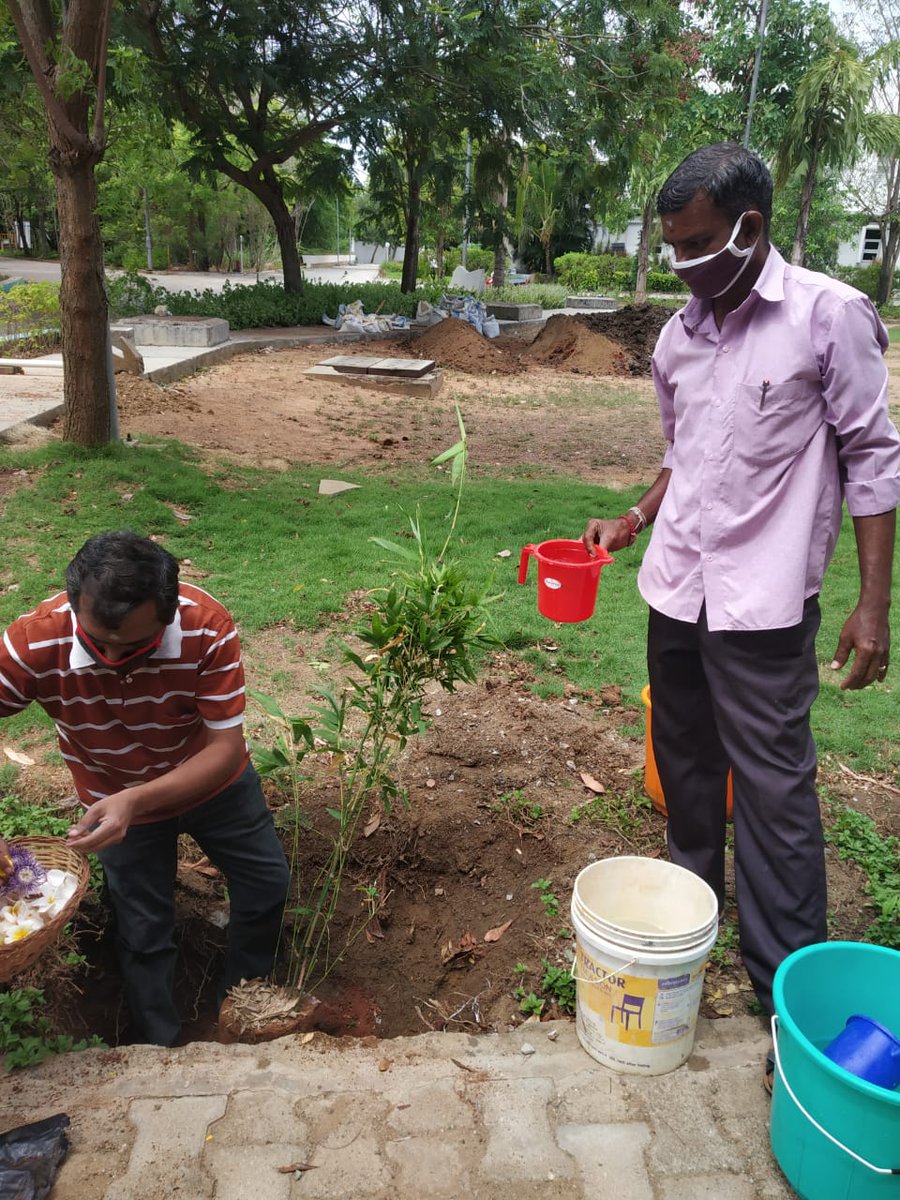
[66, 529, 178, 629]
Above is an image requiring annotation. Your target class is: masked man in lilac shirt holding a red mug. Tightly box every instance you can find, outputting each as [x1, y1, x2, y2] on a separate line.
[584, 142, 900, 1080]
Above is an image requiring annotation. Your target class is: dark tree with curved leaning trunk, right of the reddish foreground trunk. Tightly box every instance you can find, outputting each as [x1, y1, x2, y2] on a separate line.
[128, 0, 377, 292]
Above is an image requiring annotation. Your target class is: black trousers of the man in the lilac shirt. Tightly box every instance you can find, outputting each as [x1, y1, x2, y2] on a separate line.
[647, 596, 827, 1013]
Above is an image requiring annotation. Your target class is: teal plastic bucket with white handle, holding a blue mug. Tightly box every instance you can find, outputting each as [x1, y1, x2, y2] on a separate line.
[769, 942, 900, 1200]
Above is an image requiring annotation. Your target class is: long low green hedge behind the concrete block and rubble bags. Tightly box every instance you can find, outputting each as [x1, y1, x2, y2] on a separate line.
[107, 274, 442, 329]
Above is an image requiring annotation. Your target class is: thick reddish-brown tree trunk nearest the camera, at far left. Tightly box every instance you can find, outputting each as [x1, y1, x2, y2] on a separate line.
[8, 0, 115, 446]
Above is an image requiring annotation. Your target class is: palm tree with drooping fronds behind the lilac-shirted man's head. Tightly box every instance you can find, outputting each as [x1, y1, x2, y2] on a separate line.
[775, 42, 900, 266]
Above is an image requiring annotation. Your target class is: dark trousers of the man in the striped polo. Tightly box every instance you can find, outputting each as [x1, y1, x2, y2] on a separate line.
[100, 767, 289, 1045]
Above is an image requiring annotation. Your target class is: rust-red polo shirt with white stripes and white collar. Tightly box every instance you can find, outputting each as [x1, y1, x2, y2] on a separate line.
[0, 583, 246, 821]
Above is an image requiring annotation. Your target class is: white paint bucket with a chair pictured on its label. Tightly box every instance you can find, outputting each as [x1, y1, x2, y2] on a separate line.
[571, 857, 719, 1075]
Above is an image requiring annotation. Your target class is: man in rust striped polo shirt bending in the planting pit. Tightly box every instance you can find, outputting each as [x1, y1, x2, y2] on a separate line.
[0, 532, 289, 1045]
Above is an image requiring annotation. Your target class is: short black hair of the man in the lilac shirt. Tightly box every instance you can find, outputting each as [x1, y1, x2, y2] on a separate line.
[656, 142, 772, 236]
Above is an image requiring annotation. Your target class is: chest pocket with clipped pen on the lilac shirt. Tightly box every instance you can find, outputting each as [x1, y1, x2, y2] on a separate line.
[734, 379, 826, 466]
